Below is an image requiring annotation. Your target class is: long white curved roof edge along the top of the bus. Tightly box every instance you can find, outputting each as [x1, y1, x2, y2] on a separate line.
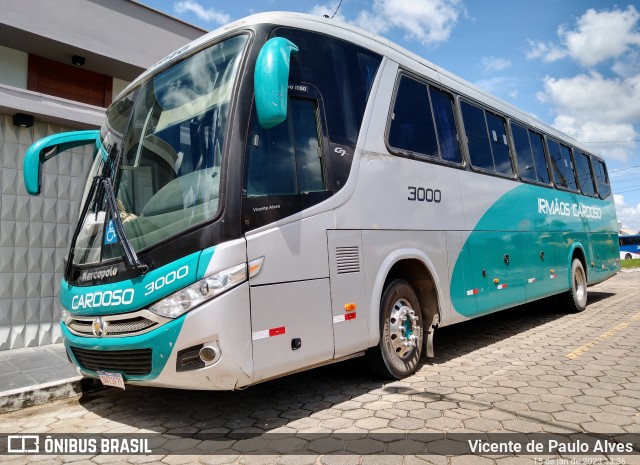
[125, 11, 593, 158]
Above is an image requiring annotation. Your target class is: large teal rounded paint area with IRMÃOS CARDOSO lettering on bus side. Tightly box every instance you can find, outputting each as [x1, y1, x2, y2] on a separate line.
[450, 184, 619, 317]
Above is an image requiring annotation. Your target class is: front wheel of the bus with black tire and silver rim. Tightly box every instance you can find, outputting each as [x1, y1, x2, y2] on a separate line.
[367, 279, 424, 379]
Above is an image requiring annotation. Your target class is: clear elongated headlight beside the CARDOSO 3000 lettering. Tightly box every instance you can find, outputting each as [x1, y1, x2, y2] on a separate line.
[149, 263, 247, 318]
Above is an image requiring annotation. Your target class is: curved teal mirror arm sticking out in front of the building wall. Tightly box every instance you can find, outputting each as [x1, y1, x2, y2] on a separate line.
[22, 130, 100, 195]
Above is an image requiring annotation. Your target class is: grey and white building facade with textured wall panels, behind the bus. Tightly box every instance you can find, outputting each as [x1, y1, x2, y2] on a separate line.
[0, 0, 205, 351]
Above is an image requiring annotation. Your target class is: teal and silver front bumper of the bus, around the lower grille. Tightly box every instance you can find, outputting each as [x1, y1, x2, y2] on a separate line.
[61, 283, 253, 390]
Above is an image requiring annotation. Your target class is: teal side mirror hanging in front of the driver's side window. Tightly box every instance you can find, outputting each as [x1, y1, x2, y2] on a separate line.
[253, 37, 298, 129]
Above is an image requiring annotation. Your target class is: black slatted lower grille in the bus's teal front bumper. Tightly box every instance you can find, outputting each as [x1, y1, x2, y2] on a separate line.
[71, 347, 151, 375]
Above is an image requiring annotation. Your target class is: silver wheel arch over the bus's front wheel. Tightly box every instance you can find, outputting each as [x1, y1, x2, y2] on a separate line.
[369, 249, 443, 347]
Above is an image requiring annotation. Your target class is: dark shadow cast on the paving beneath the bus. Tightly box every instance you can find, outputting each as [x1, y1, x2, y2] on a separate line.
[80, 292, 614, 438]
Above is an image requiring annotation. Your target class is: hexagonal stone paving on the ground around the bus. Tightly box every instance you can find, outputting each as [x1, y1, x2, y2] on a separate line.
[0, 273, 640, 465]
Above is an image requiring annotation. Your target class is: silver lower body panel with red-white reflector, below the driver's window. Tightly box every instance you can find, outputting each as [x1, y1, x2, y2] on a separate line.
[246, 212, 334, 381]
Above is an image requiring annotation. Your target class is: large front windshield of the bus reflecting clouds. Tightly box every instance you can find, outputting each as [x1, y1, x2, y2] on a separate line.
[72, 35, 248, 264]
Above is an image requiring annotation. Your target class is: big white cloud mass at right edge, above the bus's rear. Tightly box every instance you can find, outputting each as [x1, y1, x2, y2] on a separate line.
[527, 6, 640, 162]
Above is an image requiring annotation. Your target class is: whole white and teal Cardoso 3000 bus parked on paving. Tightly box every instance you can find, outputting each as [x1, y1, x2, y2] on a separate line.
[24, 13, 620, 389]
